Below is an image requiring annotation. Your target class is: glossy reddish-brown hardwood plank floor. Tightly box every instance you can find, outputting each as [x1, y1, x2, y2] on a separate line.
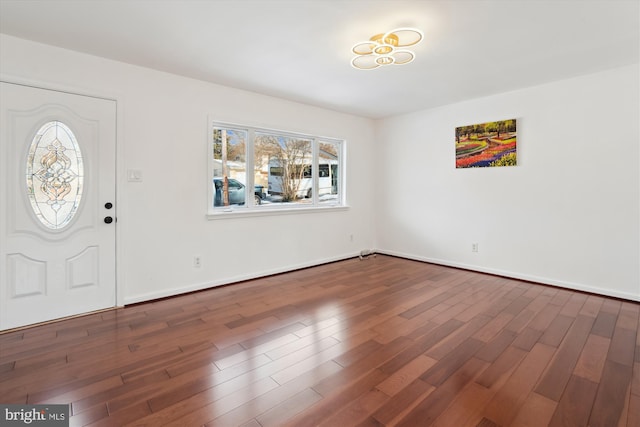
[0, 255, 640, 427]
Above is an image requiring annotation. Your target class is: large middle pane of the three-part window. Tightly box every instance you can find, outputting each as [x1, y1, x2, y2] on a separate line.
[254, 132, 313, 205]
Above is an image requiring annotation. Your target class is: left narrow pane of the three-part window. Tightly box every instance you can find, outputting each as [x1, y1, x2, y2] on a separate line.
[212, 127, 248, 208]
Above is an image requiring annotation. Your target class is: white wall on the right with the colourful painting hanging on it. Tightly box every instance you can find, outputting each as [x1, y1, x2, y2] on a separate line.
[376, 65, 640, 300]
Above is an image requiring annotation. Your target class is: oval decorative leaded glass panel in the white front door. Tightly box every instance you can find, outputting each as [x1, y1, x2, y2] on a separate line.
[26, 121, 84, 230]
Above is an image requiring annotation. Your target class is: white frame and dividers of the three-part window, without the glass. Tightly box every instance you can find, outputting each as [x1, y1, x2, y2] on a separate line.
[206, 118, 348, 220]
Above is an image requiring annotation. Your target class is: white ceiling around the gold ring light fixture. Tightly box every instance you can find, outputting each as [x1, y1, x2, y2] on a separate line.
[0, 0, 640, 118]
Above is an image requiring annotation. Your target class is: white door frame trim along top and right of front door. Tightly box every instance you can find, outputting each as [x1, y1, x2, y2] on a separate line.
[0, 72, 127, 315]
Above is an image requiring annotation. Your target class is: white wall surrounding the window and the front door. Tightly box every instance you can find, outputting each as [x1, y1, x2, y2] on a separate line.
[0, 35, 374, 303]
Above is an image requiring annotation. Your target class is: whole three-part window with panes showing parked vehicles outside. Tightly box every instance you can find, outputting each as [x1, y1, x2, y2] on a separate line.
[209, 123, 344, 214]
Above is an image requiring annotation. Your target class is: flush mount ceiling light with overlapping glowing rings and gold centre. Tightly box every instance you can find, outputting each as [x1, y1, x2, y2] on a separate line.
[351, 28, 423, 70]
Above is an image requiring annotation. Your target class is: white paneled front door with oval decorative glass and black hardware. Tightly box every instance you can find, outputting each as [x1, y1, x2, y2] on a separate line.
[0, 82, 116, 330]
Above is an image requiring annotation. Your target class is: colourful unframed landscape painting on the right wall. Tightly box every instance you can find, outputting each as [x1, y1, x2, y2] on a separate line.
[456, 119, 517, 168]
